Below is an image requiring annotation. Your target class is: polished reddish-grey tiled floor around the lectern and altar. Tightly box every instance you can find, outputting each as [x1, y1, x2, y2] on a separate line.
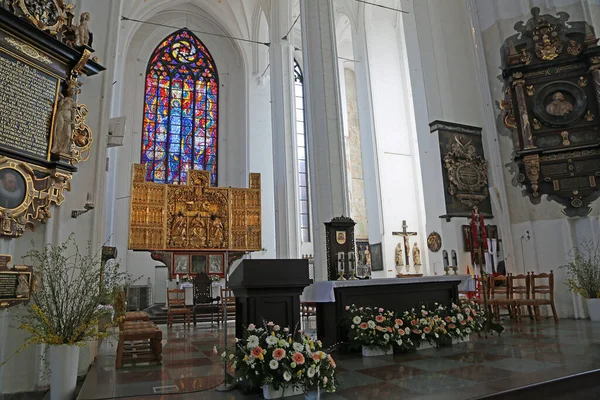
[78, 320, 600, 400]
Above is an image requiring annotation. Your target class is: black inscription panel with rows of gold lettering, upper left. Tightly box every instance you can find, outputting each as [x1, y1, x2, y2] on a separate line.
[0, 51, 59, 160]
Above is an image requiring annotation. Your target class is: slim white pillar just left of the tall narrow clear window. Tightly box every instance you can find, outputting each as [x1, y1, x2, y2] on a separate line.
[269, 0, 300, 258]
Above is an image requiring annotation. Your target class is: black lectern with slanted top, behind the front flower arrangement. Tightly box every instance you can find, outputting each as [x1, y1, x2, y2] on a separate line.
[229, 259, 312, 338]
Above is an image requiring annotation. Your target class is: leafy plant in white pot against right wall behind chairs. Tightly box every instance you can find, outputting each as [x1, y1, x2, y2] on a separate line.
[561, 239, 600, 321]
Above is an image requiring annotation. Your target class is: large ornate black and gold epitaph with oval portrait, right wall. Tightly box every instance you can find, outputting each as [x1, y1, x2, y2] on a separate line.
[500, 7, 600, 217]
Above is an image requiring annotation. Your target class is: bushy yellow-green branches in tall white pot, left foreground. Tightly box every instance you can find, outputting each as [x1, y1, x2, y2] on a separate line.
[4, 234, 127, 400]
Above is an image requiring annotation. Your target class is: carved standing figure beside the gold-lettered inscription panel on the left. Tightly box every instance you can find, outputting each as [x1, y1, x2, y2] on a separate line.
[50, 80, 77, 154]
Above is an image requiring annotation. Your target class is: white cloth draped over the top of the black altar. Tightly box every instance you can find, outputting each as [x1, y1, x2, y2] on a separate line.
[300, 275, 475, 303]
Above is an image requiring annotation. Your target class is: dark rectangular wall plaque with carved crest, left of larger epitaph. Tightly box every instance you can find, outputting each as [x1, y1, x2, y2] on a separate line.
[430, 121, 492, 220]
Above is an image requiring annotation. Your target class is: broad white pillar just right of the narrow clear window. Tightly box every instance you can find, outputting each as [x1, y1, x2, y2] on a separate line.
[300, 0, 349, 280]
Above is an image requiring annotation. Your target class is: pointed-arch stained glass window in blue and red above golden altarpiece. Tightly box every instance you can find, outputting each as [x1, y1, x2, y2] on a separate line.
[142, 29, 219, 185]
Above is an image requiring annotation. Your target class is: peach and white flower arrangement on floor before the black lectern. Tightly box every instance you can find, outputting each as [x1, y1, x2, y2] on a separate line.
[221, 322, 338, 392]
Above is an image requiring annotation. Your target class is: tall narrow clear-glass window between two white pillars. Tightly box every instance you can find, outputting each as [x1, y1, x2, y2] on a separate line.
[294, 60, 310, 242]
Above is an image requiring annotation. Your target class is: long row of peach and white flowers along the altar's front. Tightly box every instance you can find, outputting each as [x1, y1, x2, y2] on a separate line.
[346, 300, 485, 351]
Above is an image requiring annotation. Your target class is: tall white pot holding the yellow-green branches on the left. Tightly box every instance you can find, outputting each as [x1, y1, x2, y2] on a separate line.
[48, 344, 79, 400]
